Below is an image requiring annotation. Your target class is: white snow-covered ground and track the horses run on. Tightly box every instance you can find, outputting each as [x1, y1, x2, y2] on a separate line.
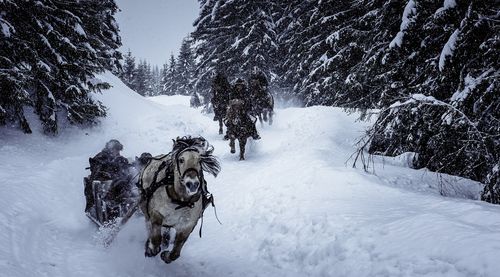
[0, 74, 500, 277]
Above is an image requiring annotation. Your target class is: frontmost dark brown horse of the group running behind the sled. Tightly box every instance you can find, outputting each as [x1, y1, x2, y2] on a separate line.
[224, 99, 255, 160]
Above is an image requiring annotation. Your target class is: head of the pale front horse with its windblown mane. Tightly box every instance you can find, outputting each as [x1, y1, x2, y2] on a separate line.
[172, 137, 220, 199]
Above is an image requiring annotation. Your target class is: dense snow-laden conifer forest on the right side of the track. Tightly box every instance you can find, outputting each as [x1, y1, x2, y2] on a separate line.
[187, 0, 500, 203]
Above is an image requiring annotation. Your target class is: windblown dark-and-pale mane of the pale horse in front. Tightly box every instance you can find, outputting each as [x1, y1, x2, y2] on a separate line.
[169, 136, 221, 177]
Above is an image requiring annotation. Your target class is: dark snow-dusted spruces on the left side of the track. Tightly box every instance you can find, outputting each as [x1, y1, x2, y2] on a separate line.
[0, 0, 121, 134]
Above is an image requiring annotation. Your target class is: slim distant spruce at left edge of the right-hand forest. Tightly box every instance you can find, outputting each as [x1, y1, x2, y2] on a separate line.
[174, 37, 195, 95]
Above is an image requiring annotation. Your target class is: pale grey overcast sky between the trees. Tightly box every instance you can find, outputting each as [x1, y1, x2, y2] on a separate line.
[116, 0, 199, 66]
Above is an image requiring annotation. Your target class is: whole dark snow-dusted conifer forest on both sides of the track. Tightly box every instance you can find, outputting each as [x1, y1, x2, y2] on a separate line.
[0, 0, 500, 204]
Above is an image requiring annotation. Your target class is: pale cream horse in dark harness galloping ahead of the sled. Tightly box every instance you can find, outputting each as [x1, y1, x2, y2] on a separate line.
[140, 137, 220, 263]
